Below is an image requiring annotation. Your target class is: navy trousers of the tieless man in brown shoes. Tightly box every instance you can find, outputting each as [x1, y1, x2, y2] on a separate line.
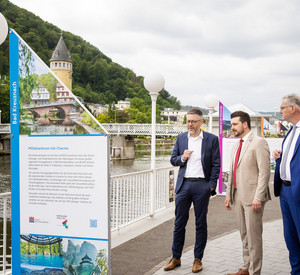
[172, 179, 210, 259]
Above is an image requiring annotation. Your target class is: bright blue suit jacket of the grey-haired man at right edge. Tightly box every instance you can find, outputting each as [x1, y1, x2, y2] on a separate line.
[274, 126, 300, 203]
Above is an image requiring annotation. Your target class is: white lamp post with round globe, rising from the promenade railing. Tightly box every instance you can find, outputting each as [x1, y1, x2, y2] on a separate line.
[144, 73, 165, 216]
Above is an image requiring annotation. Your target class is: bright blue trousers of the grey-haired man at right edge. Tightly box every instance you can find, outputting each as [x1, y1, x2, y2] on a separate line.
[280, 184, 300, 275]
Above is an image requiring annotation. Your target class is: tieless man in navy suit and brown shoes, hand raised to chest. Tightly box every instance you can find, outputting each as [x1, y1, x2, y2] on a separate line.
[164, 109, 220, 273]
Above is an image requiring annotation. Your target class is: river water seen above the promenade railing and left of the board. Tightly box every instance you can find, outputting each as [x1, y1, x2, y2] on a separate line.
[0, 148, 172, 193]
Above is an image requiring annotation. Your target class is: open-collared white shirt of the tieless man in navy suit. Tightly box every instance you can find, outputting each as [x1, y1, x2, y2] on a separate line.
[184, 130, 204, 178]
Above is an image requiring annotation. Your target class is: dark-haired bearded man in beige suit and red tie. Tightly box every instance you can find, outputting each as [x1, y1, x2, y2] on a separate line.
[224, 111, 271, 275]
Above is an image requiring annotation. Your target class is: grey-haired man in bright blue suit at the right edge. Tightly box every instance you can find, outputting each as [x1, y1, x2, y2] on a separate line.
[273, 94, 300, 275]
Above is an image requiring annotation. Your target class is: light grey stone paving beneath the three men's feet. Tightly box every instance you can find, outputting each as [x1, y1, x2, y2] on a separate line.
[152, 220, 290, 275]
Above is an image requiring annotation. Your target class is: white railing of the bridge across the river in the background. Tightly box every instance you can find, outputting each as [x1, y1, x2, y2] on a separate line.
[101, 123, 186, 136]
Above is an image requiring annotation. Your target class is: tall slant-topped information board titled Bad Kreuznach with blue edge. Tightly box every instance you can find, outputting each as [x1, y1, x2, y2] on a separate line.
[10, 30, 110, 274]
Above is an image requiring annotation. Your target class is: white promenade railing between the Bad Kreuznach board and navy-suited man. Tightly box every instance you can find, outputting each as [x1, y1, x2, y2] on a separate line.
[110, 167, 178, 231]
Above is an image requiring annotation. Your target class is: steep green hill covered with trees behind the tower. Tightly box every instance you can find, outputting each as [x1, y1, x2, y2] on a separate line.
[0, 0, 181, 122]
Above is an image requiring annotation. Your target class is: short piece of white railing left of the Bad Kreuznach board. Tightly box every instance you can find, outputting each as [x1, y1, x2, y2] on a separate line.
[0, 192, 11, 274]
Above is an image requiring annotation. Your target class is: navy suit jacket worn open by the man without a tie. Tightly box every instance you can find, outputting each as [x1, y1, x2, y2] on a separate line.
[170, 131, 220, 194]
